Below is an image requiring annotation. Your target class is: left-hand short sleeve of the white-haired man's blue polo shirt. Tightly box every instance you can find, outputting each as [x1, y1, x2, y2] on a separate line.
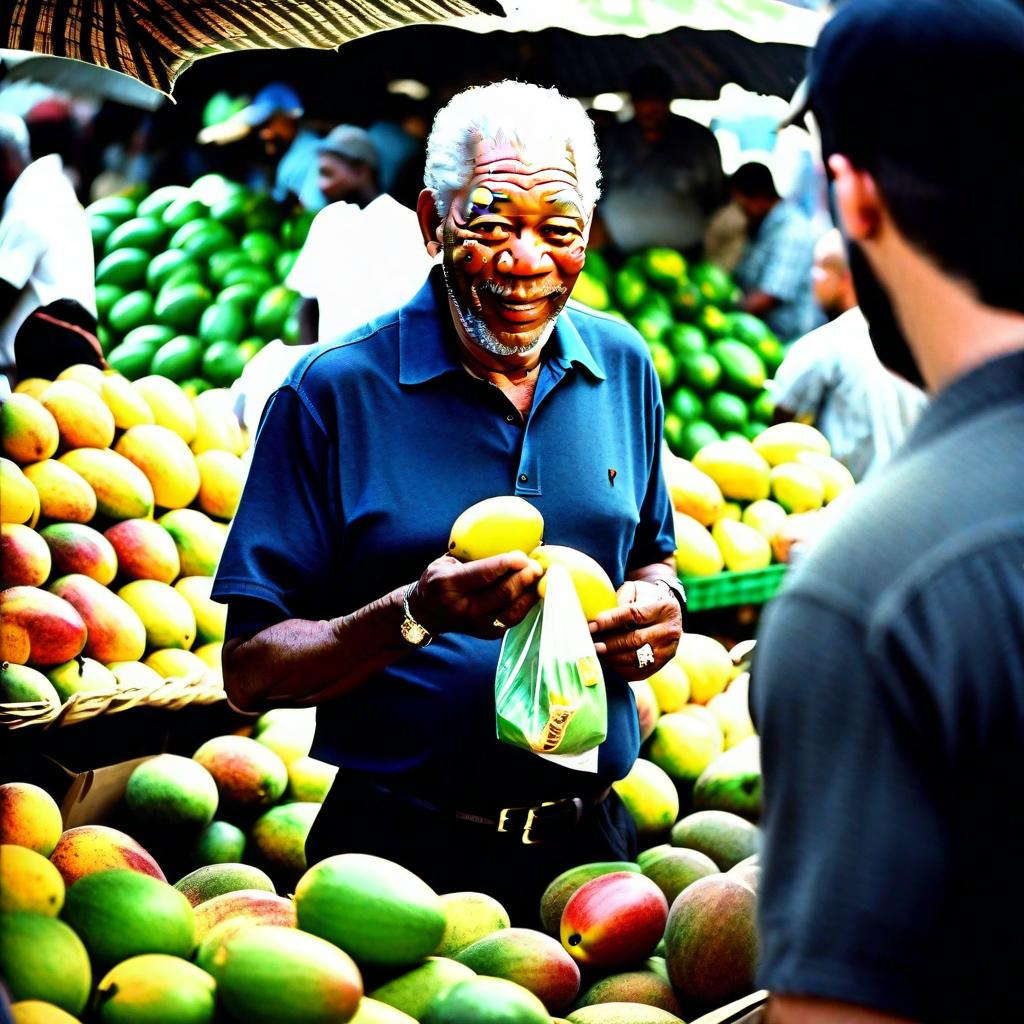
[213, 385, 343, 625]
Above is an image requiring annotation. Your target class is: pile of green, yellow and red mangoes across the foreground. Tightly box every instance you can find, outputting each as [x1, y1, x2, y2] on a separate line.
[0, 671, 760, 1024]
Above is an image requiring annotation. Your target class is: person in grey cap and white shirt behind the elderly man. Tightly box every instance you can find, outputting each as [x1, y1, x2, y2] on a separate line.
[231, 125, 431, 430]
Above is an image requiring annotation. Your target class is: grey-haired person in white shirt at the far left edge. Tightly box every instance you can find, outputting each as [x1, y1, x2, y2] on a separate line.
[0, 114, 96, 387]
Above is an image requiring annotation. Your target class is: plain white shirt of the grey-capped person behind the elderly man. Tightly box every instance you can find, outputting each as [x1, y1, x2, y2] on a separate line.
[231, 194, 433, 430]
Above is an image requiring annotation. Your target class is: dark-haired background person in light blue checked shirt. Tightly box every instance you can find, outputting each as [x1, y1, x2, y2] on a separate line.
[729, 161, 815, 341]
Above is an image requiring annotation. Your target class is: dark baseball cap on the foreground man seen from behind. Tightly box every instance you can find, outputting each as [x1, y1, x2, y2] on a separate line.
[787, 0, 1024, 179]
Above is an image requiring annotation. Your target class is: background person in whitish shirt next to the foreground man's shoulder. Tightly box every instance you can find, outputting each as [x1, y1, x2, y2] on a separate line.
[769, 229, 928, 480]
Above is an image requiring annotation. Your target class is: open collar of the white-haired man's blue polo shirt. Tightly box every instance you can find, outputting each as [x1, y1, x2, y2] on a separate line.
[398, 266, 606, 384]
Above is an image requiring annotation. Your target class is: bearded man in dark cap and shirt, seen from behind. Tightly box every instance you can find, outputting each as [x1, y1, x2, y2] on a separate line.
[751, 0, 1024, 1024]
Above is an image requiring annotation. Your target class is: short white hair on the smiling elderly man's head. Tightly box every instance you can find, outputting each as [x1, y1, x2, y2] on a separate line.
[423, 81, 601, 218]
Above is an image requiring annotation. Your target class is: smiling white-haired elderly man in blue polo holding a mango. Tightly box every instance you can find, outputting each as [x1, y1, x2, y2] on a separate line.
[214, 82, 682, 924]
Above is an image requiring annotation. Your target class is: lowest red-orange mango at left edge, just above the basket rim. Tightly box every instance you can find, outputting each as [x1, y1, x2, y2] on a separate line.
[0, 584, 87, 666]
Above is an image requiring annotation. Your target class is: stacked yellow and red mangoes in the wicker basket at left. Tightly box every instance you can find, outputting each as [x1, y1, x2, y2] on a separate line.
[0, 366, 249, 707]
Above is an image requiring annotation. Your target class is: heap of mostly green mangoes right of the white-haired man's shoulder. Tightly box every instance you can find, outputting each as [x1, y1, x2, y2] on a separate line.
[572, 248, 783, 459]
